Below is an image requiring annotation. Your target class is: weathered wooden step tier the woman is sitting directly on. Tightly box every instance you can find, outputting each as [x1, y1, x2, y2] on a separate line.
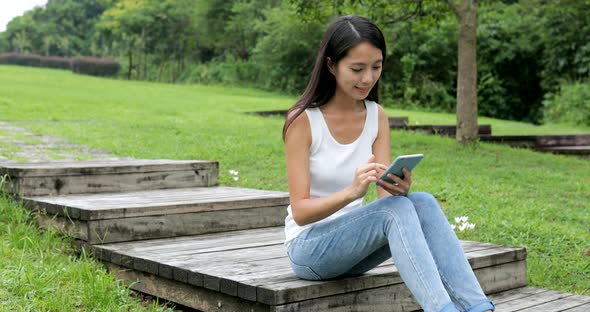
[80, 227, 527, 311]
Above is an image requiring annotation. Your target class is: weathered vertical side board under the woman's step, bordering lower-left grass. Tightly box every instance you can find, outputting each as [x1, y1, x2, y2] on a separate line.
[107, 263, 270, 312]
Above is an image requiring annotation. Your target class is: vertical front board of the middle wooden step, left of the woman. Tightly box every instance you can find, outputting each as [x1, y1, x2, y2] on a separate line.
[88, 206, 287, 244]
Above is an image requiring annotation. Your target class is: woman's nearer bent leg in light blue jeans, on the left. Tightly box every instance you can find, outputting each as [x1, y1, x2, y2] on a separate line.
[289, 196, 456, 312]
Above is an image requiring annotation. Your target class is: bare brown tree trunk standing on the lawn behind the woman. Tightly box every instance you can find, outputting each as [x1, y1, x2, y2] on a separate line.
[447, 0, 478, 144]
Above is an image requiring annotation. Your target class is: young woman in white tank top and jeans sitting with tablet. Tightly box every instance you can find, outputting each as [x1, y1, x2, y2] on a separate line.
[283, 16, 494, 312]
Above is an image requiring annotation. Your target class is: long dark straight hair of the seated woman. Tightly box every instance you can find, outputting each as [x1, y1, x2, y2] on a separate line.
[283, 15, 386, 140]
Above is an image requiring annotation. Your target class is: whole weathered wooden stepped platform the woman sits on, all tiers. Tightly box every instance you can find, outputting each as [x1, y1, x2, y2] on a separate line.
[0, 160, 588, 312]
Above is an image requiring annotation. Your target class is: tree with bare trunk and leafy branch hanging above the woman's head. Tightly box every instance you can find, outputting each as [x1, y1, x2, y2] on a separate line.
[291, 0, 478, 144]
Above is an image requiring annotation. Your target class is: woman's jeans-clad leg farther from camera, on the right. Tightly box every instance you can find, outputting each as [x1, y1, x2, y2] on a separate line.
[408, 193, 494, 311]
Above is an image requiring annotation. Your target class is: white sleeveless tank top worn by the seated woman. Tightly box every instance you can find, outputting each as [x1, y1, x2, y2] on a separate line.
[285, 101, 379, 246]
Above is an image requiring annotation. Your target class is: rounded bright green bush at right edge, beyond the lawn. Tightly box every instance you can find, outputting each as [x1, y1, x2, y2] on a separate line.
[543, 82, 590, 126]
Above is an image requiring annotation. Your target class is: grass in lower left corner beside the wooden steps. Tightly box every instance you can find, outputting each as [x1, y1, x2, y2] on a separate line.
[0, 181, 170, 311]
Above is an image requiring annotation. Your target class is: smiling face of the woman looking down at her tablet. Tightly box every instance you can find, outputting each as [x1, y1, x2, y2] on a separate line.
[328, 42, 383, 100]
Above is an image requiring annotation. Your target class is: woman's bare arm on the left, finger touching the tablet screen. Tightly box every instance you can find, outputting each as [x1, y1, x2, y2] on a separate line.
[285, 112, 378, 226]
